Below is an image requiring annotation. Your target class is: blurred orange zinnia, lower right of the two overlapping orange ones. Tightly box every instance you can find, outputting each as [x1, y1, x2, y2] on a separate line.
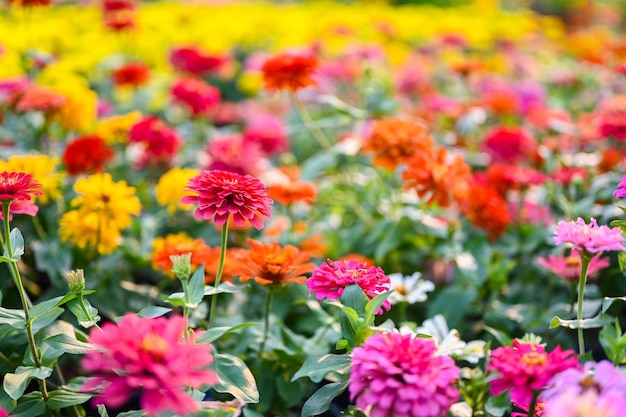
[402, 149, 471, 207]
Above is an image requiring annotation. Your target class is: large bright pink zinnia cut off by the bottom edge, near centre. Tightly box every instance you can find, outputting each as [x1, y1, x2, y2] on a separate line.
[348, 333, 461, 417]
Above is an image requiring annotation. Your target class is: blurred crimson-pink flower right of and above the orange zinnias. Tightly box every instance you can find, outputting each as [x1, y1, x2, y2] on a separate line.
[483, 126, 537, 164]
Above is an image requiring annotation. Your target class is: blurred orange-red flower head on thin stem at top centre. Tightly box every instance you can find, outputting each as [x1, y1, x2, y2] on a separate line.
[261, 53, 319, 91]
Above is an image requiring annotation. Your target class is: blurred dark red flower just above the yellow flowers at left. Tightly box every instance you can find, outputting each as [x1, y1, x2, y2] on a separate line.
[63, 135, 115, 175]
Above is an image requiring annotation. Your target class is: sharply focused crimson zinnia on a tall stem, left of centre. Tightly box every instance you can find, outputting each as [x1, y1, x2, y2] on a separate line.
[180, 170, 273, 230]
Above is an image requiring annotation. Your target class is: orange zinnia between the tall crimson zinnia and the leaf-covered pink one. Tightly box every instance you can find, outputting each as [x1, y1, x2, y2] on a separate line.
[233, 238, 315, 285]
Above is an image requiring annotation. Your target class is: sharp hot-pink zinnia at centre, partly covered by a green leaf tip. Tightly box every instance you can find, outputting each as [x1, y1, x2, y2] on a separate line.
[306, 259, 391, 313]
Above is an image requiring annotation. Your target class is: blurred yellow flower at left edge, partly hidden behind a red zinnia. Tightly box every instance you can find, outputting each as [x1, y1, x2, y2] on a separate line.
[0, 154, 63, 204]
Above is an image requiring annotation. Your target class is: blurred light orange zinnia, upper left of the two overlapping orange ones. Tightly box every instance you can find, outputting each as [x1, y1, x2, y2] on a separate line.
[363, 119, 433, 170]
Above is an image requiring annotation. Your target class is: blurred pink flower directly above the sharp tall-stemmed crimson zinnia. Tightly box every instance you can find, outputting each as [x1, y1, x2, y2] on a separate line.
[205, 134, 267, 176]
